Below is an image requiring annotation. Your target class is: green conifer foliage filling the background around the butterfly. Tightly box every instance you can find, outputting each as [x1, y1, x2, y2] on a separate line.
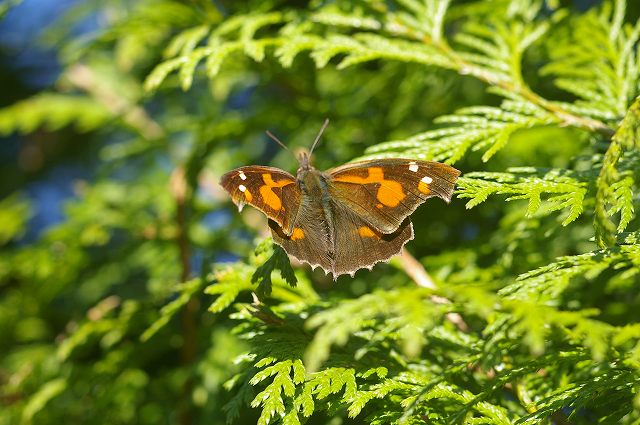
[0, 0, 640, 425]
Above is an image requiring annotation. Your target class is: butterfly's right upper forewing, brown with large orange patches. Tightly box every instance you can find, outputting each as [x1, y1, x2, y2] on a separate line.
[326, 158, 460, 233]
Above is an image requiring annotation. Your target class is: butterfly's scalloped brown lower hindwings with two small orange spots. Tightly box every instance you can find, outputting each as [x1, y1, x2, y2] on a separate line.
[269, 195, 413, 280]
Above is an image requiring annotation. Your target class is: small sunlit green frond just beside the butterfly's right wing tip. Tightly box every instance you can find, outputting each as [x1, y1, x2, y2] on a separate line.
[458, 168, 587, 226]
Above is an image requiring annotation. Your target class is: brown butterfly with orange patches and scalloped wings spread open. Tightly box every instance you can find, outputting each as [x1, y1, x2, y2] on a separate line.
[220, 120, 460, 280]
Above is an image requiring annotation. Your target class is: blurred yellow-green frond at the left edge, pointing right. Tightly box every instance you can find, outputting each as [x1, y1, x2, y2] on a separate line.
[0, 93, 112, 135]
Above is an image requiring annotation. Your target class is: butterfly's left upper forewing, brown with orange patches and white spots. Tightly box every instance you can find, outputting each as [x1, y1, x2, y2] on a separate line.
[220, 165, 301, 235]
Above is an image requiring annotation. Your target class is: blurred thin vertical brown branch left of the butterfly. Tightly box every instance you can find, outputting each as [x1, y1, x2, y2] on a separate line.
[169, 168, 199, 425]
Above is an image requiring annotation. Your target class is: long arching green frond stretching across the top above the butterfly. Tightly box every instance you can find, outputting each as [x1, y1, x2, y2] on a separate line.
[145, 1, 616, 139]
